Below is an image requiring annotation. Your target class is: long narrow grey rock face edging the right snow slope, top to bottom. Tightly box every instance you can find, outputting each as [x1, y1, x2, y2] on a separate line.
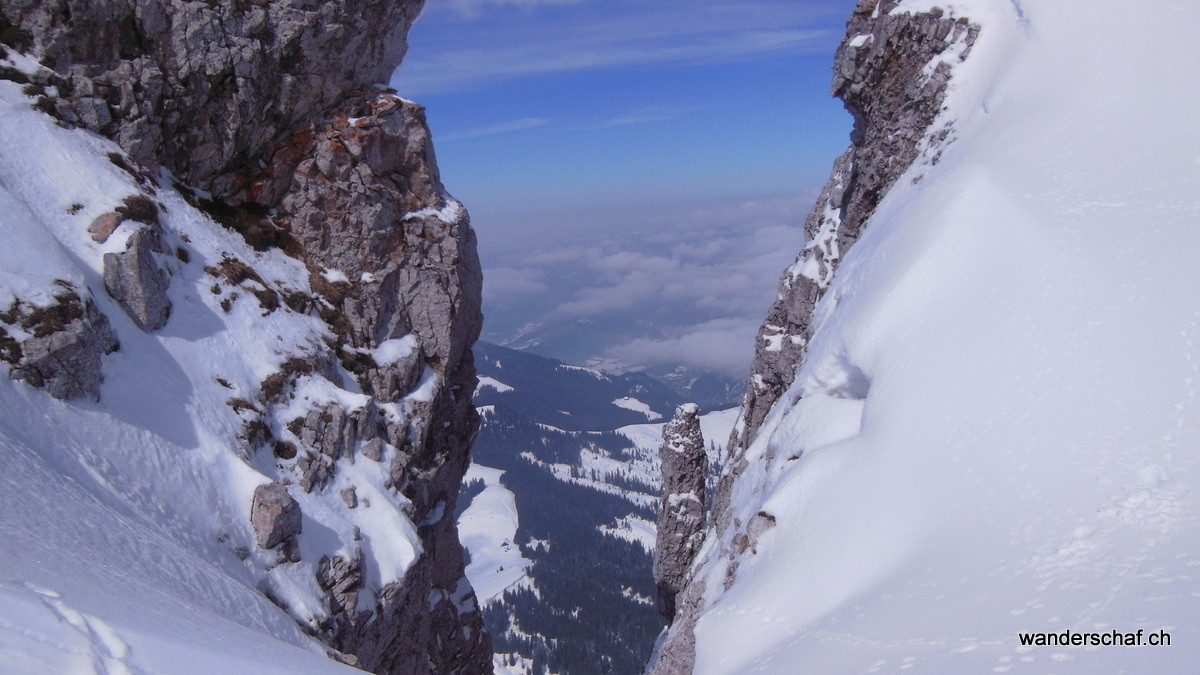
[648, 0, 978, 675]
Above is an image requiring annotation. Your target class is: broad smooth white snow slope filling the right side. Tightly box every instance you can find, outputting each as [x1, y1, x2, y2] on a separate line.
[696, 0, 1200, 674]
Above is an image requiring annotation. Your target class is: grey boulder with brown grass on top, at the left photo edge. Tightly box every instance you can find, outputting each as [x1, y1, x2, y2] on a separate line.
[4, 288, 119, 401]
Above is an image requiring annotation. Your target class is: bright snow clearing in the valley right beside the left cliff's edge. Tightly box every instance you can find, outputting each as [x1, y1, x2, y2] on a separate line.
[458, 464, 533, 604]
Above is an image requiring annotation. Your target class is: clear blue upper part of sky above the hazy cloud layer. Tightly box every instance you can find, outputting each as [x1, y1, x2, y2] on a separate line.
[394, 0, 854, 210]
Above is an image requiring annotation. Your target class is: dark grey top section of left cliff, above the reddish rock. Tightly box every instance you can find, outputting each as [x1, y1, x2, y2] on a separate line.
[4, 0, 422, 192]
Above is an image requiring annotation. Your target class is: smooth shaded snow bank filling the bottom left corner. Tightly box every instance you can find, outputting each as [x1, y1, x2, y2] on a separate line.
[0, 382, 352, 674]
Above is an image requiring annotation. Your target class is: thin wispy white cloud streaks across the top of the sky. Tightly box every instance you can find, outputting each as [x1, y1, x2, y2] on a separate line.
[394, 0, 832, 95]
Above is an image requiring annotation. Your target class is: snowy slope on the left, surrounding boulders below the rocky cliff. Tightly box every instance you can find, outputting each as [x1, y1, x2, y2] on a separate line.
[0, 61, 432, 673]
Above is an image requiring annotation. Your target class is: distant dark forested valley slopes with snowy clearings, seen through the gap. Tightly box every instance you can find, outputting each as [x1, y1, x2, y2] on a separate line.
[458, 344, 736, 674]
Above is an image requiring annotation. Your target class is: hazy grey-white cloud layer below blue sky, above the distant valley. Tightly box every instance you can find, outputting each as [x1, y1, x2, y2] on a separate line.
[484, 195, 812, 377]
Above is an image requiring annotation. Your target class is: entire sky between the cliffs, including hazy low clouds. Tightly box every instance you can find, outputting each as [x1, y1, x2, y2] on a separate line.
[392, 0, 856, 372]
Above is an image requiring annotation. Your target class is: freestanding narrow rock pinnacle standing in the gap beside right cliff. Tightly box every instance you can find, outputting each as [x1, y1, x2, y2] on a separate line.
[654, 404, 708, 622]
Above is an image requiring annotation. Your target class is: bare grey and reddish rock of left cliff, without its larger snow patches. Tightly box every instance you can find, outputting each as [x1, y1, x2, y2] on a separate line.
[0, 0, 491, 673]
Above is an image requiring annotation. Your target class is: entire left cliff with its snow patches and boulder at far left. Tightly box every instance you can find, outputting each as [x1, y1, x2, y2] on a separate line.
[0, 0, 491, 673]
